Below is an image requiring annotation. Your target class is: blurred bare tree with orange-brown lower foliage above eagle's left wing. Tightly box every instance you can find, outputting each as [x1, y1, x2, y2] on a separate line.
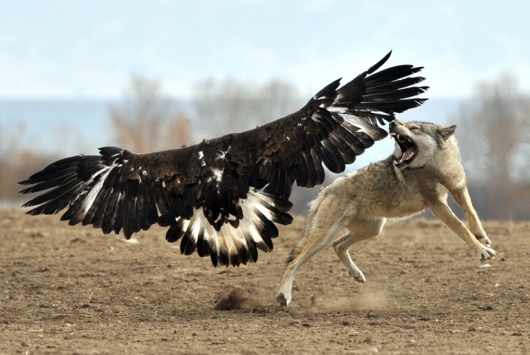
[110, 76, 193, 153]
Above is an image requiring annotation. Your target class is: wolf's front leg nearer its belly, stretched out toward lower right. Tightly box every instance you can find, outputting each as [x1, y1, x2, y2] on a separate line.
[426, 199, 497, 262]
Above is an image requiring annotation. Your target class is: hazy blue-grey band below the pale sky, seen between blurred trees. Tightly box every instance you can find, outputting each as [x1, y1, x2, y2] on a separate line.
[0, 97, 466, 172]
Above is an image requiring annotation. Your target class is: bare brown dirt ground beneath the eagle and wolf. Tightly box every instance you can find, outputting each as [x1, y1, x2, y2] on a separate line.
[0, 210, 530, 355]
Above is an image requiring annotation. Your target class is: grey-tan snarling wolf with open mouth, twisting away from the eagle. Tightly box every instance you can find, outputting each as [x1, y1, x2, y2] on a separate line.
[276, 120, 497, 306]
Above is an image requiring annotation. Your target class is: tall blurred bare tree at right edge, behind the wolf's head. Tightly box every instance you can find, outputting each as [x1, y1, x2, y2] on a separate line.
[455, 75, 530, 219]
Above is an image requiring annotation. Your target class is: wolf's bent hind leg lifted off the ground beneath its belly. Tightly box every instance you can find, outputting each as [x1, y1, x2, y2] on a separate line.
[332, 218, 386, 283]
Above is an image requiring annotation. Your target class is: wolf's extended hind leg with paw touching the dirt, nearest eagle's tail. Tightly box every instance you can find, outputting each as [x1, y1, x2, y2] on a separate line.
[276, 198, 349, 306]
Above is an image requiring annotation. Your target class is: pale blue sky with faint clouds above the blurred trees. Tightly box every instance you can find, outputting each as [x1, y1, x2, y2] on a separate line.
[0, 0, 530, 99]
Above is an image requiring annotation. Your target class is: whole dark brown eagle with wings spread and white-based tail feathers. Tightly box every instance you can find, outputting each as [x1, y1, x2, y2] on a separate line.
[20, 53, 427, 266]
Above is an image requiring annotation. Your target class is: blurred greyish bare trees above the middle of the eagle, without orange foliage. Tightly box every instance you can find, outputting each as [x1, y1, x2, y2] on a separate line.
[194, 78, 301, 136]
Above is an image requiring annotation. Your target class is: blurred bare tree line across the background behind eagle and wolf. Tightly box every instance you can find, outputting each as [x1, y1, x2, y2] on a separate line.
[0, 76, 530, 220]
